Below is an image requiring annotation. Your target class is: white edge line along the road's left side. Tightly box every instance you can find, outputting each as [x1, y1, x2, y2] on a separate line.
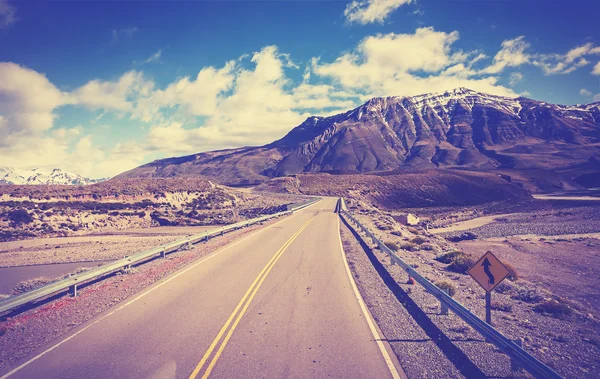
[0, 200, 322, 379]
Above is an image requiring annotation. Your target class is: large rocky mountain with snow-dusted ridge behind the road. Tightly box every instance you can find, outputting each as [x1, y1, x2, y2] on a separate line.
[120, 88, 600, 185]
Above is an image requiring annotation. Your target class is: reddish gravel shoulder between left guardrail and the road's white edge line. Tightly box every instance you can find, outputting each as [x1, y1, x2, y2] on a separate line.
[0, 220, 277, 369]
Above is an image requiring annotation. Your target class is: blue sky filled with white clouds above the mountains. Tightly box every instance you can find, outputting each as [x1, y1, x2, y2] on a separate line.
[0, 0, 600, 177]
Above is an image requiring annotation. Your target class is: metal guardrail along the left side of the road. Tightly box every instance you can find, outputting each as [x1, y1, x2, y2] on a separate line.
[0, 198, 321, 314]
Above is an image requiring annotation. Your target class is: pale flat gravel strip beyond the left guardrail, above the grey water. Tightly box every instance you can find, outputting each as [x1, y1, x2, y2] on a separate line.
[0, 226, 213, 267]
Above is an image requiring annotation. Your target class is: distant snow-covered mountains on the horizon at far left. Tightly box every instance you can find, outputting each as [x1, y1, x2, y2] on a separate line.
[0, 167, 106, 185]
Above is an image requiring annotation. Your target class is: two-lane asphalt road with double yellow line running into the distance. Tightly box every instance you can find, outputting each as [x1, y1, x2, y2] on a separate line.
[2, 199, 404, 378]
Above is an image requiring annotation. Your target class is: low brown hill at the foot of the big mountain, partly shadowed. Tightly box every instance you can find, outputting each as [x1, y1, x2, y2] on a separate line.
[256, 169, 530, 209]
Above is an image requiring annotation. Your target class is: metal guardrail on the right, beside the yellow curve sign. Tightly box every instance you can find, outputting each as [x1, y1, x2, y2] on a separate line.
[338, 198, 561, 379]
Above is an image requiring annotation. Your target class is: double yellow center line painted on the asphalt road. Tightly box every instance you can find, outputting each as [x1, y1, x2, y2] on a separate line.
[189, 215, 316, 379]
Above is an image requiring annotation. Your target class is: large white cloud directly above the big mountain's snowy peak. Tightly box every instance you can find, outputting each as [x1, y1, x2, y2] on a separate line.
[313, 28, 515, 96]
